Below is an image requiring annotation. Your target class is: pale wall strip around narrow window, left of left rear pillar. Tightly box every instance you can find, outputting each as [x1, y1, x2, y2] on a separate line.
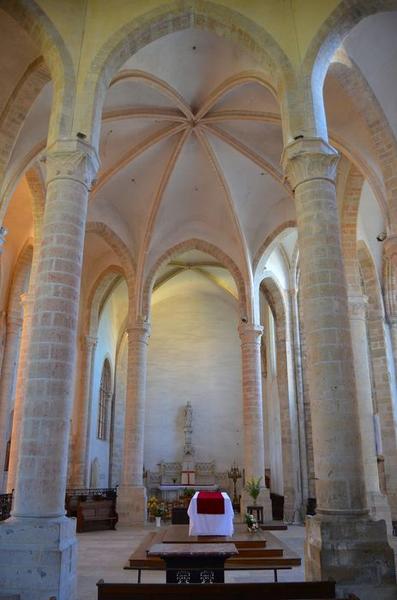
[89, 281, 127, 487]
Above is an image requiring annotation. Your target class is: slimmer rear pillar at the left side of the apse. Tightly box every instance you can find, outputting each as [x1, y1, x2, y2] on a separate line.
[117, 321, 150, 525]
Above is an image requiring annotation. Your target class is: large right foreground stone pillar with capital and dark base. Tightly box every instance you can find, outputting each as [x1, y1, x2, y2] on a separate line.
[282, 138, 395, 584]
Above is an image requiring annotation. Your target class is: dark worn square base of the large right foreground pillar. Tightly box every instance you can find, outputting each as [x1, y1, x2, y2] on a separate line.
[305, 515, 396, 585]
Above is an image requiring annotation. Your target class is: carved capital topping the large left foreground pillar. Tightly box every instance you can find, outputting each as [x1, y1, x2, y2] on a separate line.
[44, 139, 100, 190]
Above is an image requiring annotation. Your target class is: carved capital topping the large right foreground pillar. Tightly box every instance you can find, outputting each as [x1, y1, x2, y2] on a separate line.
[281, 138, 339, 191]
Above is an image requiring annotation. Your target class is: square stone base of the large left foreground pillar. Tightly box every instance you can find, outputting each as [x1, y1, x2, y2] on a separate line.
[0, 517, 77, 600]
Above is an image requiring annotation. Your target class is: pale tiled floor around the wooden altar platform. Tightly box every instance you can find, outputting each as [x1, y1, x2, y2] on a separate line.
[77, 525, 305, 600]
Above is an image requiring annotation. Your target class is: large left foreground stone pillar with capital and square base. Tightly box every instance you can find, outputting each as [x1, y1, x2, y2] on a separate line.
[0, 140, 99, 600]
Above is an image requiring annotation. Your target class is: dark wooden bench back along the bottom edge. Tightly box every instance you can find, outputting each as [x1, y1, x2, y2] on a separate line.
[97, 579, 336, 600]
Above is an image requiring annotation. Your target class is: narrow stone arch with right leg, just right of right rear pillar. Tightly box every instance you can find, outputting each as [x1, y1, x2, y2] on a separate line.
[260, 276, 302, 521]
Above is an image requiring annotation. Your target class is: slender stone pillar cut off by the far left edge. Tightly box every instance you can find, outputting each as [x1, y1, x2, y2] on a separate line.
[0, 313, 22, 492]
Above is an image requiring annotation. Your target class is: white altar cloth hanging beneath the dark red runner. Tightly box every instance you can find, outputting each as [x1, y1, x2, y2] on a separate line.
[187, 492, 234, 536]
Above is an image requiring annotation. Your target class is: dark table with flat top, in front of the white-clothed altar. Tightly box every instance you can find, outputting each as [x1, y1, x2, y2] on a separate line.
[148, 543, 238, 584]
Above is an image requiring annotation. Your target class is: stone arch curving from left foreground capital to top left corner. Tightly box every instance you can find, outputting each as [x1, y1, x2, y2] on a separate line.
[1, 0, 76, 144]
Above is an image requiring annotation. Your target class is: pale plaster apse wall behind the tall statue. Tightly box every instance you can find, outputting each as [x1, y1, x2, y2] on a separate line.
[144, 271, 243, 471]
